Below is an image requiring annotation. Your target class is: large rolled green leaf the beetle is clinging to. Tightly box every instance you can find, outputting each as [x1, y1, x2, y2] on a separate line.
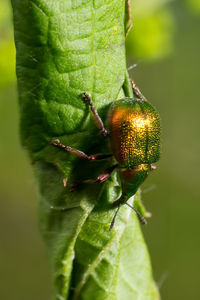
[12, 0, 159, 300]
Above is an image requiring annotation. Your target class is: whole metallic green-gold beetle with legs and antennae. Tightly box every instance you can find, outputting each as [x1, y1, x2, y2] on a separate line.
[51, 80, 160, 230]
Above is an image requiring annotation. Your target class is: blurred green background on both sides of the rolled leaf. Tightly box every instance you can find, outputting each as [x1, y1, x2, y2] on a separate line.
[0, 0, 200, 300]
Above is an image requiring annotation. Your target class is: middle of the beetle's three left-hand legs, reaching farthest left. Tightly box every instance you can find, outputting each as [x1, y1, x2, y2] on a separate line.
[51, 140, 113, 160]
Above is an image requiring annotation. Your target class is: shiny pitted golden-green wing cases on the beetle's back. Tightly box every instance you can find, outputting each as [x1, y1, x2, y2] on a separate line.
[109, 98, 160, 168]
